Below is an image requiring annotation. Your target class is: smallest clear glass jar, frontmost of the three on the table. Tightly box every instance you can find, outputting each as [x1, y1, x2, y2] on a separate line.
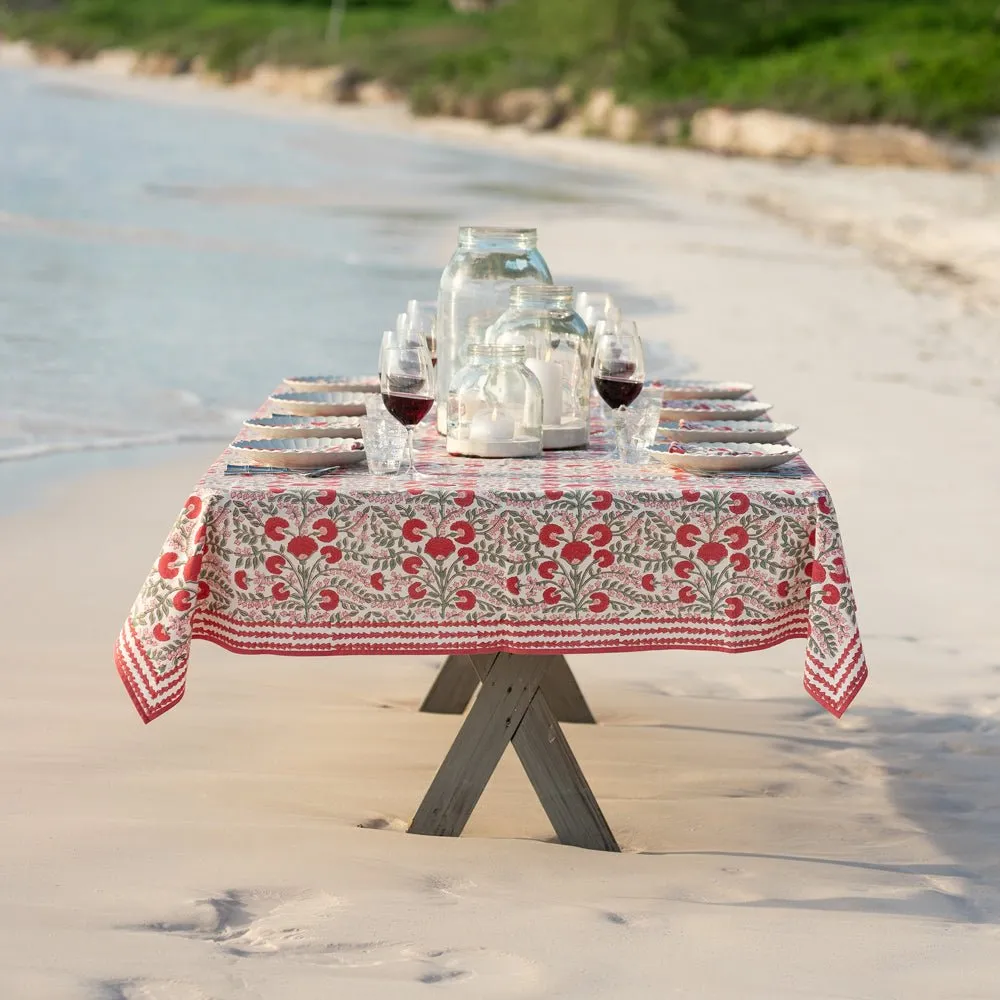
[447, 344, 542, 458]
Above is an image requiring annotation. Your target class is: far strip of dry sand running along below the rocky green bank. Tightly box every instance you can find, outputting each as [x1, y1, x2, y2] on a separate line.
[0, 42, 1000, 315]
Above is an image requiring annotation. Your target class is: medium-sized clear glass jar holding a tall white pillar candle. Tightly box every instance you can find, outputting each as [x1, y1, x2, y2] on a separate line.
[489, 285, 593, 450]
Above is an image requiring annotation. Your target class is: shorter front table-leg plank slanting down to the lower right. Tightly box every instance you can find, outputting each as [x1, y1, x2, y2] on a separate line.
[512, 685, 620, 851]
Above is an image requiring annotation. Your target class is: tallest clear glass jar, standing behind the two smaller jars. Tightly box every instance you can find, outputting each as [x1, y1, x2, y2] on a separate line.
[437, 226, 552, 434]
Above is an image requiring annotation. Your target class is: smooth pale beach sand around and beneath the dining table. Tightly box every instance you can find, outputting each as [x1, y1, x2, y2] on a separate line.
[0, 52, 1000, 1000]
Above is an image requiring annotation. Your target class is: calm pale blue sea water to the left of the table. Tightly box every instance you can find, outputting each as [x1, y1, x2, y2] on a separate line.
[0, 69, 648, 474]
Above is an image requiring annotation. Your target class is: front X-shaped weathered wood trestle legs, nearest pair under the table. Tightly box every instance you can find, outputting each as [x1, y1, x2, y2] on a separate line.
[410, 653, 619, 851]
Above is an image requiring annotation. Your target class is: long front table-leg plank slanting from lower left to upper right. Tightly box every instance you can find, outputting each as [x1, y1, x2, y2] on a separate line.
[410, 653, 549, 837]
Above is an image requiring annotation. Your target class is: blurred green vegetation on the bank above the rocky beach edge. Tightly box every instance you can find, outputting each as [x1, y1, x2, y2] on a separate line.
[0, 0, 1000, 137]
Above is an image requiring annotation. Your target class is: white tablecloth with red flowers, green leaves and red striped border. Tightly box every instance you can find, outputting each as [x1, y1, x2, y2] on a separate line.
[115, 402, 867, 722]
